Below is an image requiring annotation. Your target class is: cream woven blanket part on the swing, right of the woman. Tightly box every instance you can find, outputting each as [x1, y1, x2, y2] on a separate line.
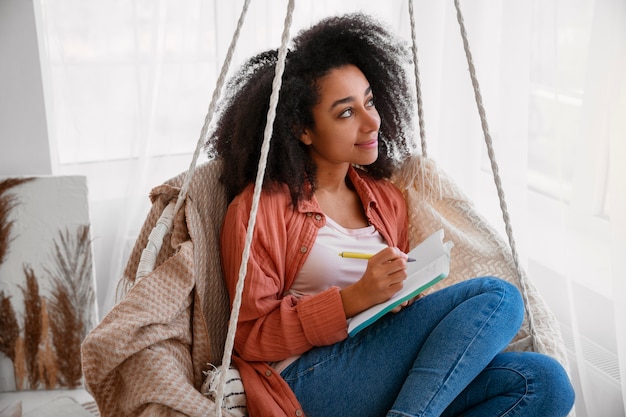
[394, 156, 568, 369]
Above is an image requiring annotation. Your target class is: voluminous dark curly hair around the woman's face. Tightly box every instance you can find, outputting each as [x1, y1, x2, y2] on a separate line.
[207, 14, 415, 204]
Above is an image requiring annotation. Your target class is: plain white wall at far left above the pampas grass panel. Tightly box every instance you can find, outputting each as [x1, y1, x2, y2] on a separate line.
[0, 0, 52, 175]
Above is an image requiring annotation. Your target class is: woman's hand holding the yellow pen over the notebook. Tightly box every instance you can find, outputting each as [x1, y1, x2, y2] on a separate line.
[341, 247, 407, 318]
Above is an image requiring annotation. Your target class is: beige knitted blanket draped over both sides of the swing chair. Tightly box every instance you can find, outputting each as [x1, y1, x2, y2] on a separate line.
[82, 156, 567, 417]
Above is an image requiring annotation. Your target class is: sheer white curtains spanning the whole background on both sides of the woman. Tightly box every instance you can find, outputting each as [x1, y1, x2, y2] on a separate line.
[35, 0, 626, 417]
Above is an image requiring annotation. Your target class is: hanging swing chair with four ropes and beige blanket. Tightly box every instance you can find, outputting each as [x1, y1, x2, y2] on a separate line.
[82, 0, 567, 417]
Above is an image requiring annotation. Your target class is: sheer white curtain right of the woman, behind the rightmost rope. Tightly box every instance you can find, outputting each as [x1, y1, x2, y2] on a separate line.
[423, 4, 626, 416]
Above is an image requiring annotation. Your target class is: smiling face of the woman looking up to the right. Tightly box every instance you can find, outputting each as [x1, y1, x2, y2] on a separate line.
[300, 65, 380, 168]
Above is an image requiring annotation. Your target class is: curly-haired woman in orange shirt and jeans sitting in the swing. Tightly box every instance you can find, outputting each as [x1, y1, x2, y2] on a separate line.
[208, 15, 574, 417]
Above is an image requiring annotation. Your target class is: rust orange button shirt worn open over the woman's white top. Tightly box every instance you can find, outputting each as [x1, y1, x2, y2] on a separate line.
[221, 167, 408, 417]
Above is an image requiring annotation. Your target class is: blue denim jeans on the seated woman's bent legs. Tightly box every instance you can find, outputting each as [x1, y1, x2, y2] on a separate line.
[281, 278, 574, 417]
